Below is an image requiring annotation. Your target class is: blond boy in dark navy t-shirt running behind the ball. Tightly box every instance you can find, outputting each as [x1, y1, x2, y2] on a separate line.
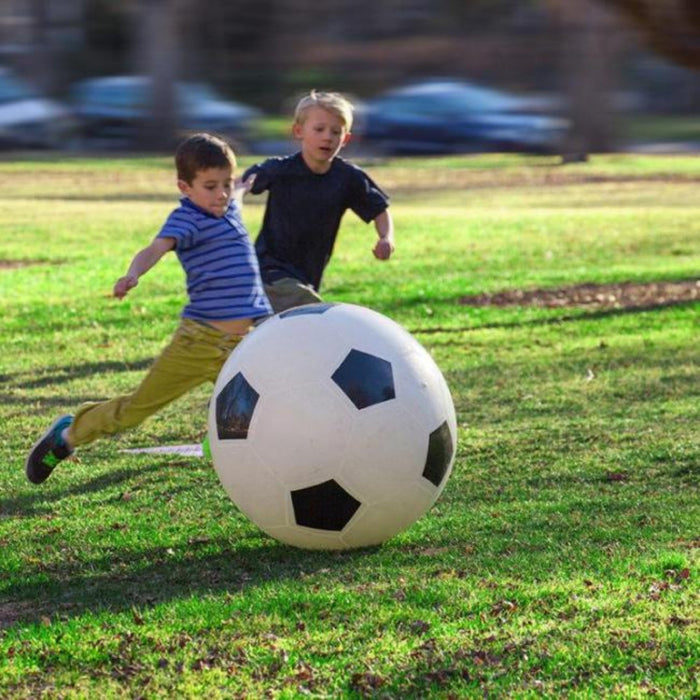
[243, 90, 394, 312]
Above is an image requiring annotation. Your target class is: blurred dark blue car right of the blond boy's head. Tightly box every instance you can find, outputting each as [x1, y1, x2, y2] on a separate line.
[358, 80, 569, 154]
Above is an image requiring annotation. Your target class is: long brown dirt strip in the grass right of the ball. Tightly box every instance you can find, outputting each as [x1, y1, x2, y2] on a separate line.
[459, 279, 700, 309]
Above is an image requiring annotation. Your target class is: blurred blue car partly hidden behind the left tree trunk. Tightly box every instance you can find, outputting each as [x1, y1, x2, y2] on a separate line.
[71, 75, 261, 146]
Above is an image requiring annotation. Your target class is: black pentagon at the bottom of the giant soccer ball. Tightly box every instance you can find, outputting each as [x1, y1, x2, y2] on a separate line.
[292, 479, 360, 532]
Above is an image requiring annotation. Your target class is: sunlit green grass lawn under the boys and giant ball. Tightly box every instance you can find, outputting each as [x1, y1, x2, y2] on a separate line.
[0, 150, 700, 699]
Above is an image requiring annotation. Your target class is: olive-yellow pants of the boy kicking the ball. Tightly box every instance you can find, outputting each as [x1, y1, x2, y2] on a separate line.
[68, 318, 241, 447]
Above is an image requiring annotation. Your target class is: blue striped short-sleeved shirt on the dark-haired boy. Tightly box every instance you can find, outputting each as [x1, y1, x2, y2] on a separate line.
[157, 197, 272, 322]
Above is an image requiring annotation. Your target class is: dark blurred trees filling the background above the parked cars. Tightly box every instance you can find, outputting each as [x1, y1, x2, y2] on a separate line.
[0, 0, 700, 151]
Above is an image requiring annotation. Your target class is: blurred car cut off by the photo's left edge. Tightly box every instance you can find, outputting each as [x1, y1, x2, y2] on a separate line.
[0, 68, 75, 148]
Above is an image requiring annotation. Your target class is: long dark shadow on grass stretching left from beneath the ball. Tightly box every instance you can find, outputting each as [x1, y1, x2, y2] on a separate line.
[0, 532, 367, 630]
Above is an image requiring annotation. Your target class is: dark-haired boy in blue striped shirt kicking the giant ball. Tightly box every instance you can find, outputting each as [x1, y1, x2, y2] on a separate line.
[25, 134, 271, 484]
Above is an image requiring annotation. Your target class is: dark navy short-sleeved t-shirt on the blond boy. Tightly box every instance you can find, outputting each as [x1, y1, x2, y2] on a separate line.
[243, 153, 389, 290]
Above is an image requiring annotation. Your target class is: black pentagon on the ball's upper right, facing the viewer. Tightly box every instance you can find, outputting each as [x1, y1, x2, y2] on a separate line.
[331, 350, 396, 409]
